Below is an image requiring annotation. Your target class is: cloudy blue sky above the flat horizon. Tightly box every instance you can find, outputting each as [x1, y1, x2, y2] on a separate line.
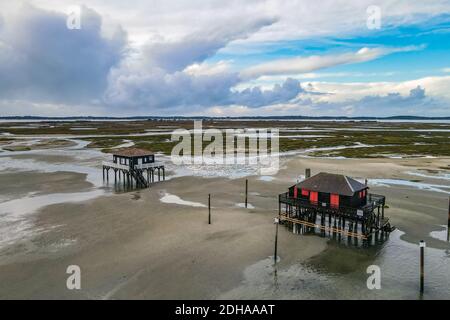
[0, 0, 450, 117]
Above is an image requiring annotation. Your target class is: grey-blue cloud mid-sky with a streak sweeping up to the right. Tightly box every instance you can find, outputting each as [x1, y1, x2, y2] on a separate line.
[104, 14, 302, 112]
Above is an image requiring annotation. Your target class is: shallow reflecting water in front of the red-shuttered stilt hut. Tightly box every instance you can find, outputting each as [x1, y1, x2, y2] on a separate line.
[219, 230, 450, 299]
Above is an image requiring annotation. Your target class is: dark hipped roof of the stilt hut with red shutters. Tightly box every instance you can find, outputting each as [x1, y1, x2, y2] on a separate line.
[297, 172, 367, 196]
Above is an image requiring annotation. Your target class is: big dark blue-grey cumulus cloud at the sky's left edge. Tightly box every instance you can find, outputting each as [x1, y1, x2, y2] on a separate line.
[0, 5, 126, 103]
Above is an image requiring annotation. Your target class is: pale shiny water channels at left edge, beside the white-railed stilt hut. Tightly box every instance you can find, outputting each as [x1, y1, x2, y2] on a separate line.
[0, 140, 110, 249]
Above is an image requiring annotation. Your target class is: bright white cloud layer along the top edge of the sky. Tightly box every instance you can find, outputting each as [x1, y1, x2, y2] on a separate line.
[12, 0, 450, 44]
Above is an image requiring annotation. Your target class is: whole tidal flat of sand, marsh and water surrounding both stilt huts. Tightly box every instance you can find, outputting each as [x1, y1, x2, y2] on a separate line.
[0, 120, 450, 299]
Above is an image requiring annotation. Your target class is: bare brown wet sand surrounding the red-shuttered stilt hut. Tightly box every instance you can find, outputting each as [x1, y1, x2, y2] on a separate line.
[0, 152, 450, 299]
